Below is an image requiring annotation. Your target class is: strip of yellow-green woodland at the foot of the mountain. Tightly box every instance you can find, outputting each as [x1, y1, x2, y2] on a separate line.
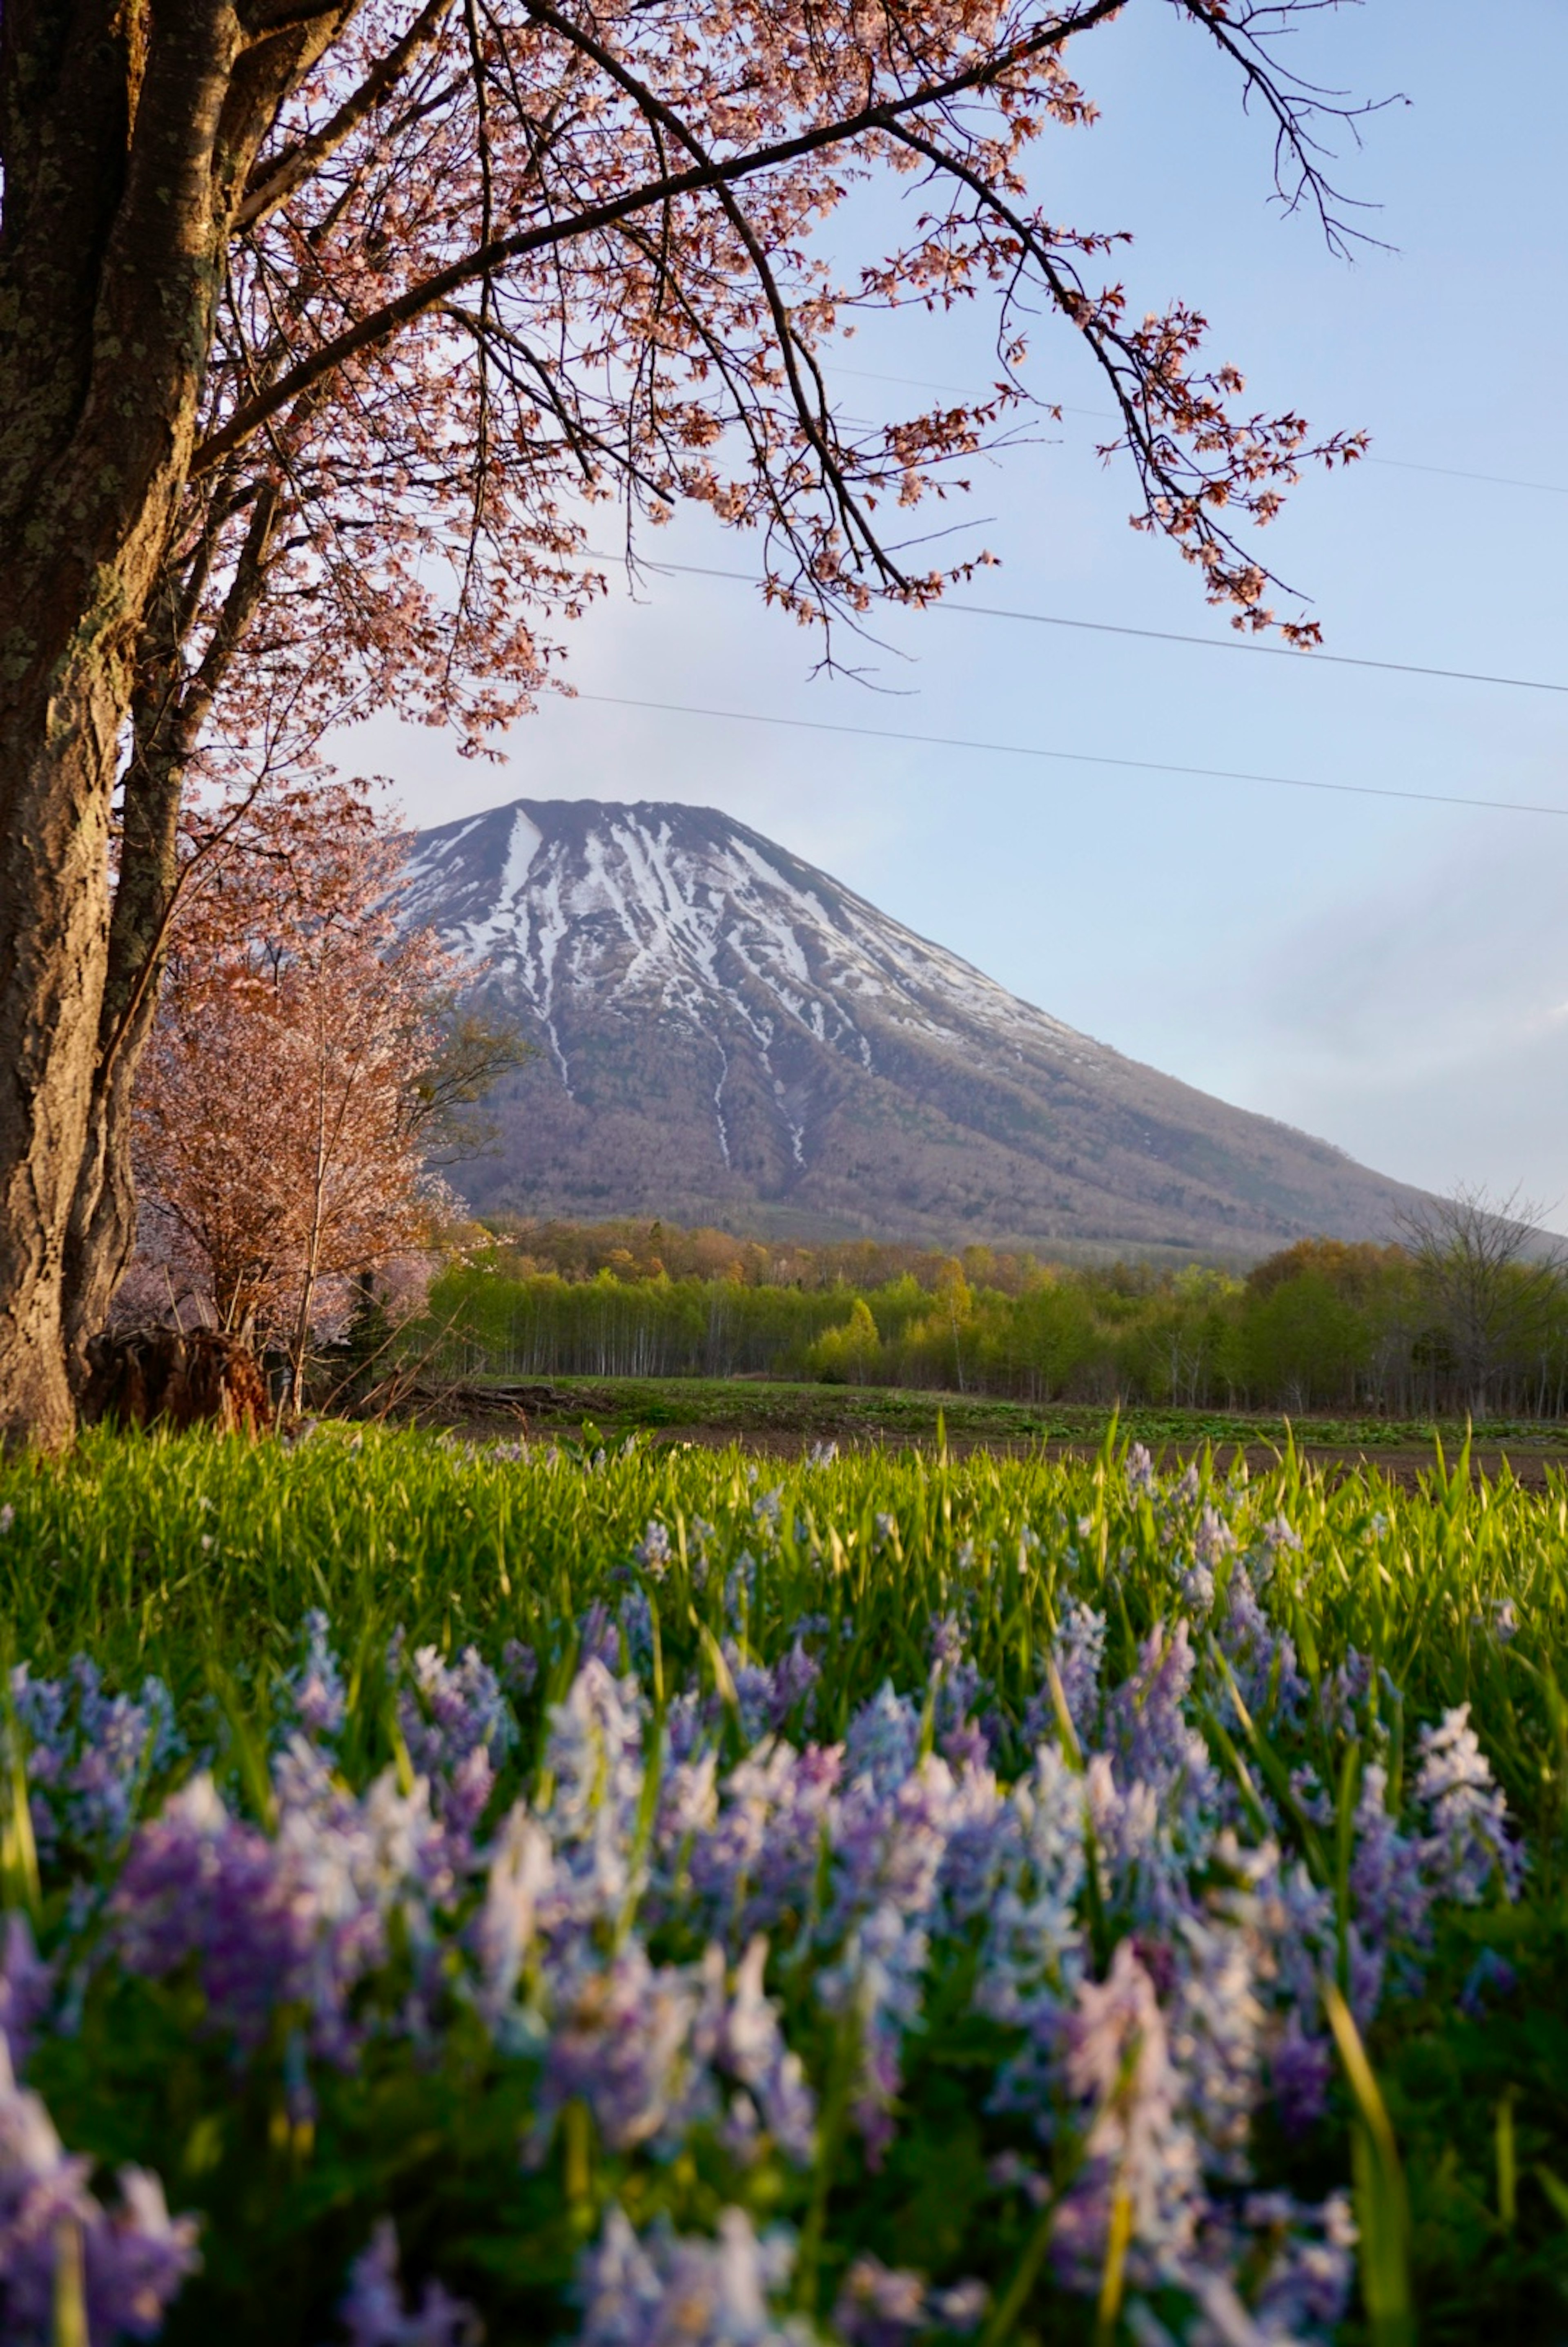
[418, 1192, 1568, 1418]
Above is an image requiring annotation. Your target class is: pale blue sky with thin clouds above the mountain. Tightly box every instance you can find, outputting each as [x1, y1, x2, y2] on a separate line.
[352, 0, 1568, 1227]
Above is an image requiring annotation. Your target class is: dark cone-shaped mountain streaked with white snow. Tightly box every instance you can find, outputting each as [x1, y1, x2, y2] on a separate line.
[408, 798, 1411, 1253]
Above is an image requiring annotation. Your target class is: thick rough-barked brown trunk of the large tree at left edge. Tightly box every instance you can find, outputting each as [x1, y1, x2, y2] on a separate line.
[0, 0, 336, 1443]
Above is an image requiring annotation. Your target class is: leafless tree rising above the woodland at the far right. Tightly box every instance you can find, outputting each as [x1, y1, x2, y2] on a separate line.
[1394, 1183, 1566, 1418]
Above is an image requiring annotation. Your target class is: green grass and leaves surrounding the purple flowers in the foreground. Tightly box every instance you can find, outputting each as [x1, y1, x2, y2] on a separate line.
[0, 1427, 1568, 2347]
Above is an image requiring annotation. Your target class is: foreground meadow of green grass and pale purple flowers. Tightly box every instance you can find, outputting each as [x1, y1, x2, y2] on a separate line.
[0, 1427, 1568, 2347]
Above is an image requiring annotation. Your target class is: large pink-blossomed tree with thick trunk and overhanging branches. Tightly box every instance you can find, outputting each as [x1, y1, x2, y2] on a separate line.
[0, 0, 1357, 1443]
